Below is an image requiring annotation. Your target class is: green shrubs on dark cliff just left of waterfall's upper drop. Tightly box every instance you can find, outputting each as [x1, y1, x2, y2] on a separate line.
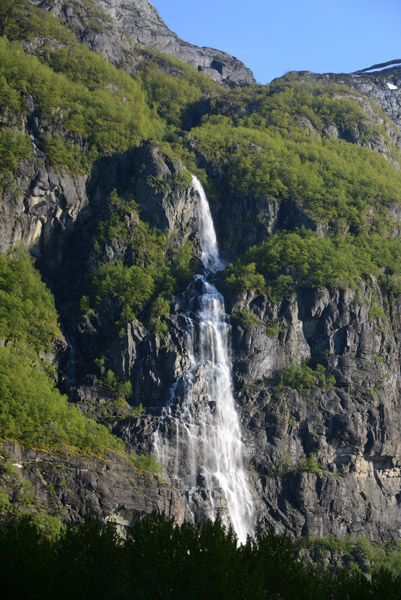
[88, 191, 193, 326]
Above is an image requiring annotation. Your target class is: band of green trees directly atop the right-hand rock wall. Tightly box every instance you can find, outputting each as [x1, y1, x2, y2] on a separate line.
[225, 228, 401, 299]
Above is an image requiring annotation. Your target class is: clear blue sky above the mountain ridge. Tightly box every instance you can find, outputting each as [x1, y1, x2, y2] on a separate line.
[152, 0, 401, 83]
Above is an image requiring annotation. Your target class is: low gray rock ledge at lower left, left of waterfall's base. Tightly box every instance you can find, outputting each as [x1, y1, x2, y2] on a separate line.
[0, 443, 186, 529]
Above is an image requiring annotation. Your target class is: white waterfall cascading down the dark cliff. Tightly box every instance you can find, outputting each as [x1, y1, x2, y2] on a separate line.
[154, 177, 255, 543]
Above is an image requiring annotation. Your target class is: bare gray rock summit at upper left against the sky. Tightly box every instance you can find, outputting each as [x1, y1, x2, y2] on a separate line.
[31, 0, 255, 85]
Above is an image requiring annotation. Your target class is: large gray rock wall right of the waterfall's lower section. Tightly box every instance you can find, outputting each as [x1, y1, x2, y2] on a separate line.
[227, 285, 401, 541]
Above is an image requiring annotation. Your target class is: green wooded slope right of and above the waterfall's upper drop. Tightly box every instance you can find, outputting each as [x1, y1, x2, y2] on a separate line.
[191, 75, 401, 299]
